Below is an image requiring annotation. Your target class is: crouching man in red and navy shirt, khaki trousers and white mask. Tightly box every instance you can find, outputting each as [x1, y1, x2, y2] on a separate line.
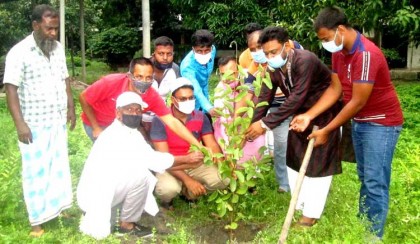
[150, 77, 226, 208]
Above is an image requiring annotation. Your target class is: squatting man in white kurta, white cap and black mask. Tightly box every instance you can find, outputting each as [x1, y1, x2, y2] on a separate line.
[77, 91, 203, 239]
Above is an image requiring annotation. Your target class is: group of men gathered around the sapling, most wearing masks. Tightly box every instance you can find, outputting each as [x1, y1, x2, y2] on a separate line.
[4, 2, 403, 239]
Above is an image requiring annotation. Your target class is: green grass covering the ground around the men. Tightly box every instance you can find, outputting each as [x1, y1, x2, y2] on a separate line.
[0, 63, 420, 243]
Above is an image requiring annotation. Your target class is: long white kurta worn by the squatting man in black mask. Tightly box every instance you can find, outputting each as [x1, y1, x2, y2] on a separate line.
[77, 120, 174, 239]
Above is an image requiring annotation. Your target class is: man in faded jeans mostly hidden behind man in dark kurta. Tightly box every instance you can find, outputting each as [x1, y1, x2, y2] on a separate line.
[243, 30, 303, 193]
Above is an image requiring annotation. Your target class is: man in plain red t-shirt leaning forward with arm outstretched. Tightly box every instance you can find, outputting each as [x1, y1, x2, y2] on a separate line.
[79, 58, 199, 148]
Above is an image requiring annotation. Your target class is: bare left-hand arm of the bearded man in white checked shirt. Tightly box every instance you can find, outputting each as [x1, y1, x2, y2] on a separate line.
[4, 83, 32, 144]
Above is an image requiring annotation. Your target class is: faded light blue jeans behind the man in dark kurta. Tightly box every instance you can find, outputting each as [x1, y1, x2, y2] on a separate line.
[272, 113, 292, 191]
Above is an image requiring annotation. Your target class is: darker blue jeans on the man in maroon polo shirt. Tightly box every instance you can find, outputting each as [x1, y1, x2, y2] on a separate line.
[352, 121, 402, 238]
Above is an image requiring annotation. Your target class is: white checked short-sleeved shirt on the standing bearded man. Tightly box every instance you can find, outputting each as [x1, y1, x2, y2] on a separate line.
[4, 33, 69, 125]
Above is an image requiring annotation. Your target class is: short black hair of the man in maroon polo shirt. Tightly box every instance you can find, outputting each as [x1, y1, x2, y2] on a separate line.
[314, 6, 350, 32]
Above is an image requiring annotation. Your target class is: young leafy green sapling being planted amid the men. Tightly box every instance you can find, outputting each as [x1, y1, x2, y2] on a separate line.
[193, 66, 272, 238]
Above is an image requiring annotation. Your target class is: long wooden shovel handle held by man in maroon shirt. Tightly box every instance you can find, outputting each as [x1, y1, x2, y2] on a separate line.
[278, 125, 318, 243]
